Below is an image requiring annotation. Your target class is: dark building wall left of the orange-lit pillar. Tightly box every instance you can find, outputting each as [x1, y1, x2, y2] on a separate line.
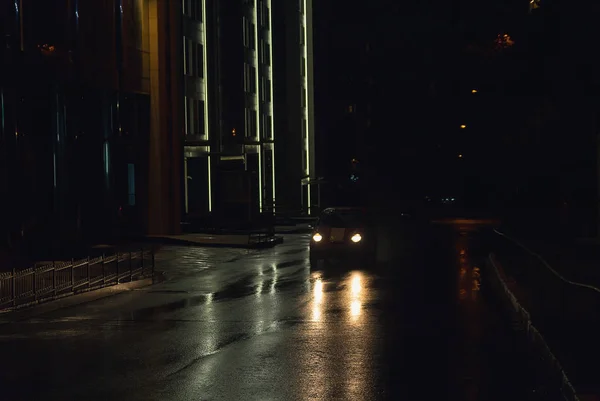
[0, 0, 155, 253]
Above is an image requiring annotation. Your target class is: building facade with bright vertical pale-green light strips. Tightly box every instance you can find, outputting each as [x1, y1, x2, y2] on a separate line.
[182, 0, 314, 225]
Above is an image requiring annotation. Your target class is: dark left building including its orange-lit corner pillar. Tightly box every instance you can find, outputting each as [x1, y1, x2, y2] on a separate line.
[0, 0, 183, 250]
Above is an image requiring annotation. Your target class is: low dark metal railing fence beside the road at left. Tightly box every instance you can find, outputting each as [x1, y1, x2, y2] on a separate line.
[0, 249, 154, 309]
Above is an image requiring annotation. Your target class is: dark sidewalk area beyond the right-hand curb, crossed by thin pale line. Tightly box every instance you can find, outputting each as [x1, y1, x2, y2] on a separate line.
[491, 230, 600, 399]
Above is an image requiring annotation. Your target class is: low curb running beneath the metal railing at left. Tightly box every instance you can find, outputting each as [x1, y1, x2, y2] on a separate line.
[0, 272, 165, 326]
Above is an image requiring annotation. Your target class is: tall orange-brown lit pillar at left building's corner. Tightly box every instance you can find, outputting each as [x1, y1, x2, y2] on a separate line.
[148, 0, 183, 234]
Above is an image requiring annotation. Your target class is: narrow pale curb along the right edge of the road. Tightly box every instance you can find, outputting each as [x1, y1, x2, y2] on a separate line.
[484, 254, 580, 401]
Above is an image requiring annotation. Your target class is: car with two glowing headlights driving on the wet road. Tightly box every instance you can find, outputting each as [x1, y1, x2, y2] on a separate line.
[310, 207, 377, 265]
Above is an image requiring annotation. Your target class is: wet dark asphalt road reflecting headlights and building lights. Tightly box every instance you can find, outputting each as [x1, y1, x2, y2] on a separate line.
[0, 222, 552, 401]
